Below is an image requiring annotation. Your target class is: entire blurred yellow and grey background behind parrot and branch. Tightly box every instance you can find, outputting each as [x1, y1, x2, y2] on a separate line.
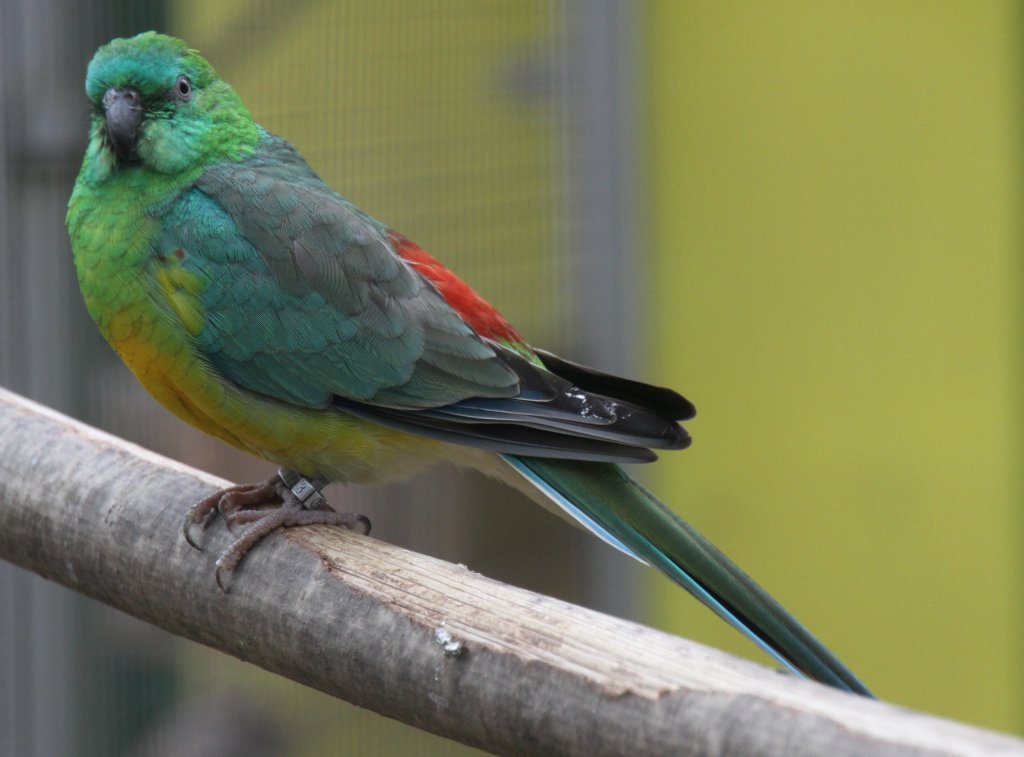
[0, 0, 1024, 755]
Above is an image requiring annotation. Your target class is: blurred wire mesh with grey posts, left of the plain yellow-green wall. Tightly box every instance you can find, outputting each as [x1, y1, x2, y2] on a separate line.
[0, 0, 632, 755]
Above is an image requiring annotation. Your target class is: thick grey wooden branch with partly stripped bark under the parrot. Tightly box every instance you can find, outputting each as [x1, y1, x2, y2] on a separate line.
[0, 389, 1024, 756]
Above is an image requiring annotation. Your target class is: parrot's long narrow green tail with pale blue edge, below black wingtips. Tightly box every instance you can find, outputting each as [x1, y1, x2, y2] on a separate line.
[502, 455, 871, 697]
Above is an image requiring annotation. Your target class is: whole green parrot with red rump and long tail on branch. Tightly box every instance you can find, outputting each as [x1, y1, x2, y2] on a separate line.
[68, 32, 869, 696]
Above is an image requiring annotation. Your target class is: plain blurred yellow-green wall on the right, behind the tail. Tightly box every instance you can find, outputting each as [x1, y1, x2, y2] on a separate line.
[646, 0, 1024, 732]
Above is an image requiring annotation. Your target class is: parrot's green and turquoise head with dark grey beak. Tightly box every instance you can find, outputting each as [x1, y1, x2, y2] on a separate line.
[85, 32, 259, 180]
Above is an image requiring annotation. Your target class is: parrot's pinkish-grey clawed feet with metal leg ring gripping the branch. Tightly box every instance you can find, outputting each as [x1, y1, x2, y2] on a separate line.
[182, 468, 370, 592]
